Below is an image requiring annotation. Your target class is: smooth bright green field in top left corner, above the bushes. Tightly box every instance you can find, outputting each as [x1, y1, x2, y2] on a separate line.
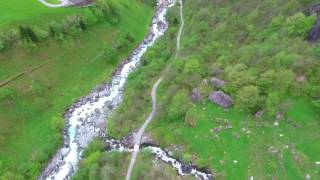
[0, 0, 81, 28]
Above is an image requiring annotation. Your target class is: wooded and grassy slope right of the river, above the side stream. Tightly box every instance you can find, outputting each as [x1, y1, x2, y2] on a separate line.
[108, 0, 320, 179]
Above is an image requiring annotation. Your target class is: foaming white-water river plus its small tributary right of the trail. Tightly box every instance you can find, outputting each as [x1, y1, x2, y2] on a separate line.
[39, 0, 211, 180]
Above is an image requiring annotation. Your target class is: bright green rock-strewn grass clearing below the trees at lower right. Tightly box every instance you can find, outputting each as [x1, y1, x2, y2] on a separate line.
[149, 98, 320, 179]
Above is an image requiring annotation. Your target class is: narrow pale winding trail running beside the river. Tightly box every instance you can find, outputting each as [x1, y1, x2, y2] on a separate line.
[126, 0, 184, 180]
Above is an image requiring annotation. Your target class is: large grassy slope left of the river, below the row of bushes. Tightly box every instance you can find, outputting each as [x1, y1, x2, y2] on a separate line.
[0, 0, 153, 179]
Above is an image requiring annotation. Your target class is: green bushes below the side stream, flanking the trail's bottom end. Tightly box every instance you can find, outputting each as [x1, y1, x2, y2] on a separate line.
[73, 141, 194, 180]
